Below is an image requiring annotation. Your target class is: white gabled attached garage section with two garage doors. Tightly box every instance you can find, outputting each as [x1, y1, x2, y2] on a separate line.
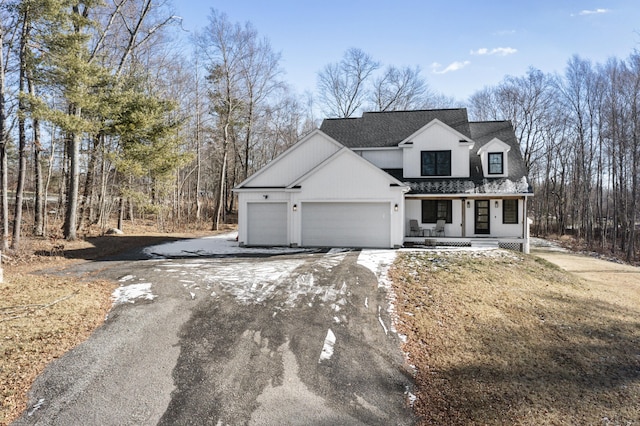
[234, 130, 409, 248]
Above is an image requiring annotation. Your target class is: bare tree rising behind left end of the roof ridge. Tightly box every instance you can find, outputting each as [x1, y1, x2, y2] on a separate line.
[318, 48, 380, 118]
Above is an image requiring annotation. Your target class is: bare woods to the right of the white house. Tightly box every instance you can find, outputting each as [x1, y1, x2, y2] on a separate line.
[469, 56, 640, 261]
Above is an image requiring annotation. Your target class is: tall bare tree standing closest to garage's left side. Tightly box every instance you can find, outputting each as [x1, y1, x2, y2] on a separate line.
[198, 10, 283, 229]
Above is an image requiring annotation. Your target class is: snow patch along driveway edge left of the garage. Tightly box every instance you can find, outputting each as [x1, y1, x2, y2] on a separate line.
[143, 232, 309, 259]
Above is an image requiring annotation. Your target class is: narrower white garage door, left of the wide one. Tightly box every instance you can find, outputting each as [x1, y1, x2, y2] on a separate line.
[247, 203, 289, 246]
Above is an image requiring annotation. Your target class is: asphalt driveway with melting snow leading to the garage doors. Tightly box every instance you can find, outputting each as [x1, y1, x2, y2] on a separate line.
[15, 238, 415, 425]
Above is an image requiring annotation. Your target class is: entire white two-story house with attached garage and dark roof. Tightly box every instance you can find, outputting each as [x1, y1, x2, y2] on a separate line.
[235, 108, 533, 251]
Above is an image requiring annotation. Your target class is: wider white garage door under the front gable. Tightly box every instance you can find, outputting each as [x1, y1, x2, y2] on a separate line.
[301, 203, 391, 248]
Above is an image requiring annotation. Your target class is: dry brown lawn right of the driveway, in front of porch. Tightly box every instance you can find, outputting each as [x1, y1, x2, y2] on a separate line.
[391, 252, 640, 425]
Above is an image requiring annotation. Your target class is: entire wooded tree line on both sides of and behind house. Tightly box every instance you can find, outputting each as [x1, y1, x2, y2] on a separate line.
[0, 0, 640, 259]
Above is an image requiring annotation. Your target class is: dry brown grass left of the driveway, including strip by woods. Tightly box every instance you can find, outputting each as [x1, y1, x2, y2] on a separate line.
[0, 223, 230, 425]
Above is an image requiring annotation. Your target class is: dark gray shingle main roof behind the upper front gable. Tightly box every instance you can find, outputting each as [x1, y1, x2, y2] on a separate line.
[320, 108, 471, 148]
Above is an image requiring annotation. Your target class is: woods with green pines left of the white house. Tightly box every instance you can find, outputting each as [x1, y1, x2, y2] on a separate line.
[0, 0, 312, 250]
